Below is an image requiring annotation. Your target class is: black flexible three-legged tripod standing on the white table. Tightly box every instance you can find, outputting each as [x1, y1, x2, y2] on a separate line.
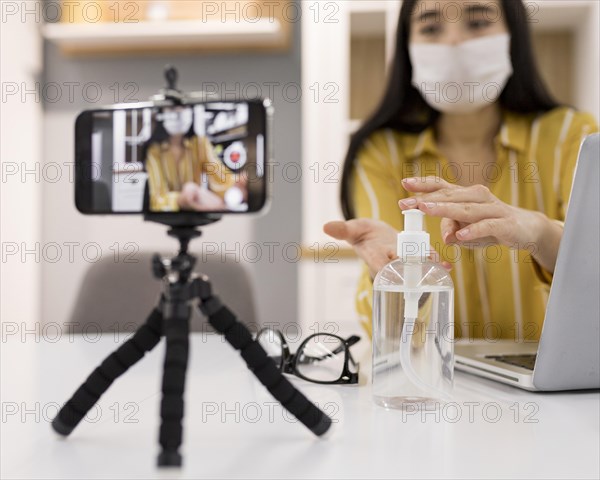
[52, 216, 331, 466]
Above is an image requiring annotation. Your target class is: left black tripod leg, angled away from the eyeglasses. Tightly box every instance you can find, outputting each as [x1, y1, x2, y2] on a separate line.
[52, 308, 162, 436]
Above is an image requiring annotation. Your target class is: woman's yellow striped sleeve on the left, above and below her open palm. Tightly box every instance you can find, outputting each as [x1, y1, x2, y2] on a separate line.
[352, 130, 406, 335]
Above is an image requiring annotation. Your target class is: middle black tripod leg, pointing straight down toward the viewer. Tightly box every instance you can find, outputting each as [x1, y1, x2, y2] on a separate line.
[158, 284, 191, 467]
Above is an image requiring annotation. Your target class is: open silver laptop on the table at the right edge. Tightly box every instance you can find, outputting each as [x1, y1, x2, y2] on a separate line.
[455, 134, 600, 391]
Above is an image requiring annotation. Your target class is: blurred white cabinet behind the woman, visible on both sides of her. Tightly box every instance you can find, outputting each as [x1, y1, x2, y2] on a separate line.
[299, 0, 600, 331]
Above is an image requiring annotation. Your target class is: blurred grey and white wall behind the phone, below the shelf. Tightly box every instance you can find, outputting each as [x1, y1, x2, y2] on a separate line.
[1, 2, 301, 334]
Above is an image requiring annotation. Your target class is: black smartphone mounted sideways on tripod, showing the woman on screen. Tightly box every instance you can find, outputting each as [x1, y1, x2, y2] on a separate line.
[75, 99, 272, 215]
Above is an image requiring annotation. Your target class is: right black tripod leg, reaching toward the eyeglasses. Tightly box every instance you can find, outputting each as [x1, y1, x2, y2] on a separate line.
[194, 277, 331, 436]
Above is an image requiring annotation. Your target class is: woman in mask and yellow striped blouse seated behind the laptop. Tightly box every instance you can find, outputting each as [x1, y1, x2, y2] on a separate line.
[325, 0, 598, 340]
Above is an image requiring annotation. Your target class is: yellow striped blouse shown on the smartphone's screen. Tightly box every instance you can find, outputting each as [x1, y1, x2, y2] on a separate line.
[146, 136, 236, 212]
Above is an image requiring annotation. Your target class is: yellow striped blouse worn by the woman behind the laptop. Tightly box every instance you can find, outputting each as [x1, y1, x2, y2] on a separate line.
[352, 107, 598, 340]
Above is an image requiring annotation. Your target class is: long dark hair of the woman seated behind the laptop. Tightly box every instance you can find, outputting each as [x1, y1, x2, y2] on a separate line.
[341, 0, 559, 219]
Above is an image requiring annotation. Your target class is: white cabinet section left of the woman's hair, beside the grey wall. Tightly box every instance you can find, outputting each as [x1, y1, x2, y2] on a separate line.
[298, 0, 400, 332]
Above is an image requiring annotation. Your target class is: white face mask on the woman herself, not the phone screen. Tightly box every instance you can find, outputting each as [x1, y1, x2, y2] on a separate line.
[409, 33, 513, 113]
